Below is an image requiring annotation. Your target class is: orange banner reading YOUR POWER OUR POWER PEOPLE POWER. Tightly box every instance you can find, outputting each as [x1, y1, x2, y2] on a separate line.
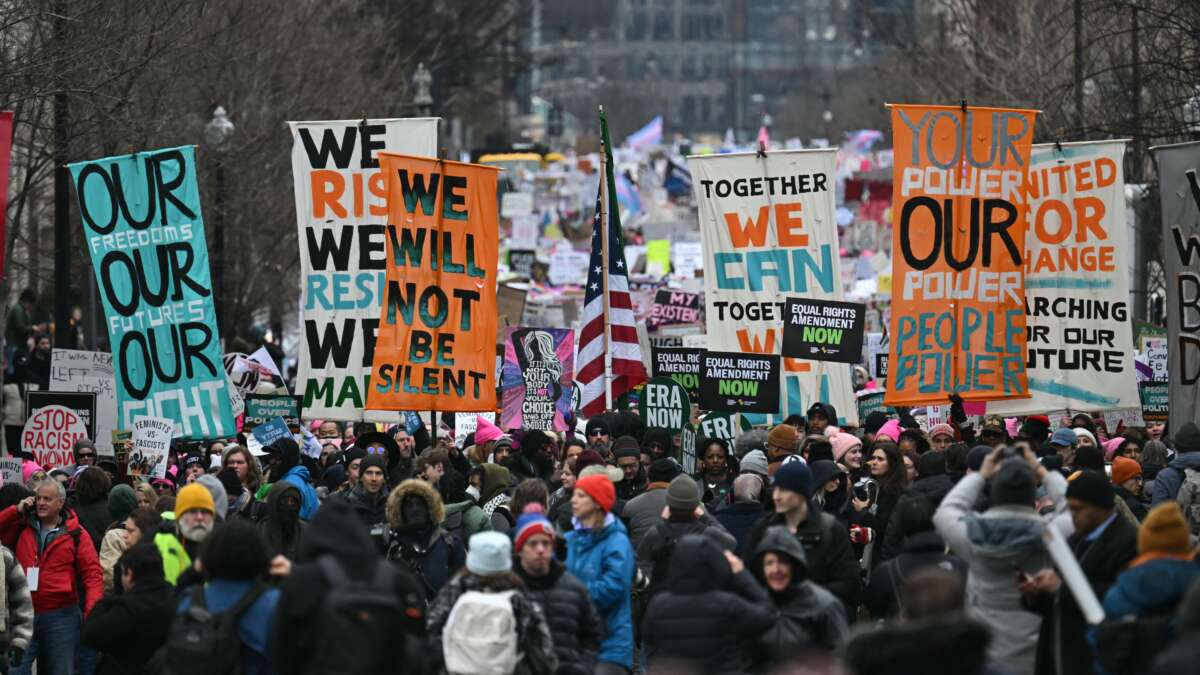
[884, 106, 1037, 406]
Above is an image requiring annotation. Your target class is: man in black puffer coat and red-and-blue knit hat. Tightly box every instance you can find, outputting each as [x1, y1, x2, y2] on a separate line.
[512, 504, 604, 675]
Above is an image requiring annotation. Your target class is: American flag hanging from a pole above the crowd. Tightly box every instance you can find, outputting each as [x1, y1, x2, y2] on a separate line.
[575, 183, 646, 417]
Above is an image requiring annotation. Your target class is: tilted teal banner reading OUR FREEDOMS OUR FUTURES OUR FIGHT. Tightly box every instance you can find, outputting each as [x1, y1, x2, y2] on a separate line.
[67, 147, 235, 438]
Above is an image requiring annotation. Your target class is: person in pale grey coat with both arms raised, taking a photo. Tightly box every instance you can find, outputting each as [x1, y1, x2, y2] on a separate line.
[934, 446, 1067, 674]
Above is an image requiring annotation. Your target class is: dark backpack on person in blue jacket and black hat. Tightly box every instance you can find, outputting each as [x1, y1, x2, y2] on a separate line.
[163, 584, 265, 675]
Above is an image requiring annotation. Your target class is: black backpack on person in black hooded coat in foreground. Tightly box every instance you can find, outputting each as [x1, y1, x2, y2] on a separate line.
[301, 555, 425, 675]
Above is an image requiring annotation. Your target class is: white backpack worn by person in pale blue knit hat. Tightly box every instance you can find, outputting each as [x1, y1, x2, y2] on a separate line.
[442, 591, 521, 675]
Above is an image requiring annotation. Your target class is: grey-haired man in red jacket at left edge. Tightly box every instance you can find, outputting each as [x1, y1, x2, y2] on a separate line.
[0, 480, 104, 675]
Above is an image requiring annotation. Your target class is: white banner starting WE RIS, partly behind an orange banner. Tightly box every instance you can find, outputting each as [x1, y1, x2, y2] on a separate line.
[290, 118, 438, 423]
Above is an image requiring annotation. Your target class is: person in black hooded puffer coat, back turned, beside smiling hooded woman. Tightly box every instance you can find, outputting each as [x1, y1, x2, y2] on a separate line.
[642, 534, 775, 675]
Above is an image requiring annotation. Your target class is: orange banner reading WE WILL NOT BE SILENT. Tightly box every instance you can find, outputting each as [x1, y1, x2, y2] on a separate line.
[367, 153, 498, 412]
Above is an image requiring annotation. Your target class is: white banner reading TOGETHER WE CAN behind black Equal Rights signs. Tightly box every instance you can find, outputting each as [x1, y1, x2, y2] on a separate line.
[688, 149, 858, 424]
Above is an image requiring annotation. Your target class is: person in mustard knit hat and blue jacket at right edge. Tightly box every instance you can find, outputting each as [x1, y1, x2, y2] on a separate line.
[1087, 502, 1200, 675]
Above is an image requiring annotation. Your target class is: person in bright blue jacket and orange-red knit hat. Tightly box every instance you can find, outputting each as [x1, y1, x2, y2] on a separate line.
[566, 474, 637, 675]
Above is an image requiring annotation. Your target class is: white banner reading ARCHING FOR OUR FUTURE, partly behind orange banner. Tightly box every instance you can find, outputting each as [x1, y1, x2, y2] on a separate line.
[988, 141, 1141, 417]
